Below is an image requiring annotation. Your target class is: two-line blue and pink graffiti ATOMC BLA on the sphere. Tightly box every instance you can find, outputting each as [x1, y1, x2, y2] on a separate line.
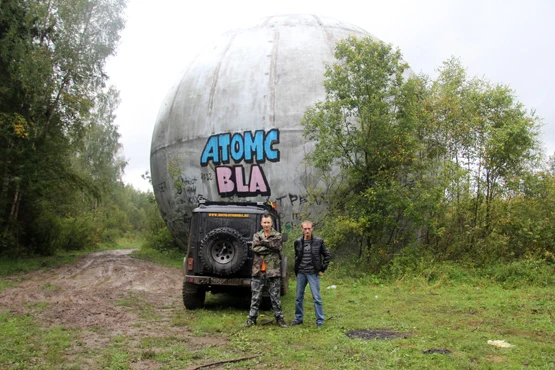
[200, 129, 280, 197]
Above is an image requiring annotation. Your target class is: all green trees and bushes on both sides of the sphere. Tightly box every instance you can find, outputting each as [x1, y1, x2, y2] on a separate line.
[0, 0, 555, 271]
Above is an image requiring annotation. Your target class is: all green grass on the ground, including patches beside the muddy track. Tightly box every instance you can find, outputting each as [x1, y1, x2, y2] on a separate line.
[0, 241, 555, 369]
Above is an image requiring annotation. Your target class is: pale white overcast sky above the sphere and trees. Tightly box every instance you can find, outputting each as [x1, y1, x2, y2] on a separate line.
[107, 0, 555, 191]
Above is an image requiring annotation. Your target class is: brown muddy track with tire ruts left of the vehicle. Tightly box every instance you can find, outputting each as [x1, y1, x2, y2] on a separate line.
[0, 250, 181, 328]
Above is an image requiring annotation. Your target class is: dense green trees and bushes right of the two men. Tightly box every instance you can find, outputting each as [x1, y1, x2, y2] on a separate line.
[302, 38, 555, 270]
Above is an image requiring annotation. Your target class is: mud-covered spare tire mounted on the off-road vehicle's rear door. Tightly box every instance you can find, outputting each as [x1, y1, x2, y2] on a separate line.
[199, 227, 248, 275]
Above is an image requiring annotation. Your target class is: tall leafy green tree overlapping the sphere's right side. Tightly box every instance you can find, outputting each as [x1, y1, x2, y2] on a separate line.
[302, 37, 432, 264]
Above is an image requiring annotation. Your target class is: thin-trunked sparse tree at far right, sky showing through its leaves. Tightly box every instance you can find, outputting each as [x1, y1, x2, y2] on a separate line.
[425, 58, 541, 253]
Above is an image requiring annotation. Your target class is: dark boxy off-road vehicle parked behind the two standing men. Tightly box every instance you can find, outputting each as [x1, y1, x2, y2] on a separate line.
[183, 201, 288, 309]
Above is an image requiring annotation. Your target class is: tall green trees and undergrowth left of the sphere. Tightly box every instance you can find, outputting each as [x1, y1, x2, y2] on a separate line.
[0, 0, 174, 256]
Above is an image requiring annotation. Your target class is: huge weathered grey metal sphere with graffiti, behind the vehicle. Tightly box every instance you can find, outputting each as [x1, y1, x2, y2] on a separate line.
[150, 14, 378, 245]
